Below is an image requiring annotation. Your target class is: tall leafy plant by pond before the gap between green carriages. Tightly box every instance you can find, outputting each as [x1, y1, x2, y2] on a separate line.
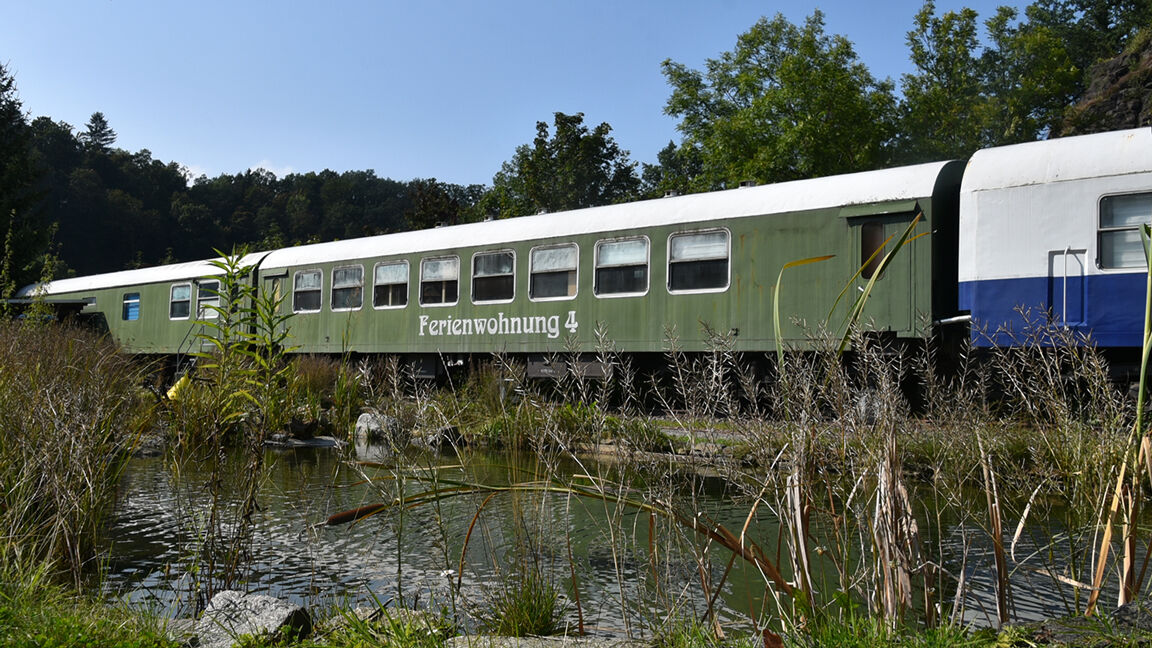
[168, 251, 306, 610]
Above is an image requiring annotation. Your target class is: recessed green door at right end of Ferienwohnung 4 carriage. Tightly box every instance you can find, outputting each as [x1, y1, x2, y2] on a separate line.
[846, 211, 926, 332]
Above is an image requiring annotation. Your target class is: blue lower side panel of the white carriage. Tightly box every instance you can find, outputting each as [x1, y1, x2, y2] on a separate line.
[960, 273, 1146, 347]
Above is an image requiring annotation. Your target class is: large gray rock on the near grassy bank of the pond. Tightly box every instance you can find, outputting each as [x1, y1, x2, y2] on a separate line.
[196, 589, 312, 648]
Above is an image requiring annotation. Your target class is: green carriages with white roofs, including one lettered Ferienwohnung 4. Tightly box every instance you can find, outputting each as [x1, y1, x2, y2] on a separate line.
[24, 157, 963, 366]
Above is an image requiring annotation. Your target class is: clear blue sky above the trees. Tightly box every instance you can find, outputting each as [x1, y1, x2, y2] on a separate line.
[0, 0, 1018, 184]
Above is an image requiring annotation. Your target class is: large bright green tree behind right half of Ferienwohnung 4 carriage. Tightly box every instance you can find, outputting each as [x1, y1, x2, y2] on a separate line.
[664, 10, 896, 190]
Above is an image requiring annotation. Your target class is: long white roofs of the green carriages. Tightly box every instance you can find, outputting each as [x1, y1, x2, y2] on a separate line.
[18, 163, 948, 296]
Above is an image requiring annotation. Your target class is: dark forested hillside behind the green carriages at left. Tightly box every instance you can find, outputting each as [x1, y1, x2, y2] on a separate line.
[30, 113, 482, 274]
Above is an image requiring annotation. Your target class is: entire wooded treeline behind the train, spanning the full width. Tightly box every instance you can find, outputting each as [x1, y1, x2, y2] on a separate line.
[0, 0, 1152, 287]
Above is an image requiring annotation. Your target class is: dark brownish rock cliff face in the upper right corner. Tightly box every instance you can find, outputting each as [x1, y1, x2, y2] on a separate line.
[1058, 28, 1152, 136]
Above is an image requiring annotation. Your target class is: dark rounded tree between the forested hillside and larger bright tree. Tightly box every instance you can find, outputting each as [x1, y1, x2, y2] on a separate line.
[477, 112, 639, 218]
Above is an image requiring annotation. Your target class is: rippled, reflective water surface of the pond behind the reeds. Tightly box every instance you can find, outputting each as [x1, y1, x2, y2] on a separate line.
[105, 447, 1110, 634]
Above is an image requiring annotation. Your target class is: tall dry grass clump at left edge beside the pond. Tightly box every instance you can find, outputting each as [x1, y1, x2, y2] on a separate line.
[0, 319, 147, 586]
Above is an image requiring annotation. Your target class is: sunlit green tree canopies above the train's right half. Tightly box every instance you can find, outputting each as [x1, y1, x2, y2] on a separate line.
[658, 0, 1152, 177]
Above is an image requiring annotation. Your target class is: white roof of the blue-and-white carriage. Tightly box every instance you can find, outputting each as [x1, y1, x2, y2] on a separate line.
[961, 127, 1152, 194]
